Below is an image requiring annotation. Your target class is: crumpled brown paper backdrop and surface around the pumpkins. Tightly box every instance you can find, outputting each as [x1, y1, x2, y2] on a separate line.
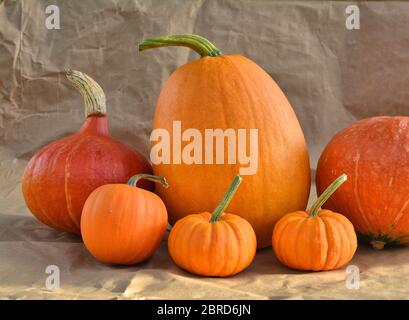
[0, 0, 409, 299]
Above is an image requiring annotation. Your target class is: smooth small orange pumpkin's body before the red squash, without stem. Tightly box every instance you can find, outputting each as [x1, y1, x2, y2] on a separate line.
[81, 184, 168, 265]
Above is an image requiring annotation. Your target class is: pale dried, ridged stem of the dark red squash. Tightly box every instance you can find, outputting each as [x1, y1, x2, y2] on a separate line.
[66, 69, 106, 117]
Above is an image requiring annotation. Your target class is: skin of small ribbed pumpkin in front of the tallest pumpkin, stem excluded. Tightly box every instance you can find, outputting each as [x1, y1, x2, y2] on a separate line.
[168, 212, 257, 277]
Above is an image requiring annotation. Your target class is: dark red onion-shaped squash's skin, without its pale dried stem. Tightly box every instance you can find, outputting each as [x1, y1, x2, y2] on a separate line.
[22, 116, 153, 233]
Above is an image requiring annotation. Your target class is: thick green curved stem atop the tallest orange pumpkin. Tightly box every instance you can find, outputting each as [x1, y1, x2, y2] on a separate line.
[138, 34, 222, 57]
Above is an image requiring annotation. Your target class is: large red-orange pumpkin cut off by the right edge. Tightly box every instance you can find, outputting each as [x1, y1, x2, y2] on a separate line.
[316, 117, 409, 243]
